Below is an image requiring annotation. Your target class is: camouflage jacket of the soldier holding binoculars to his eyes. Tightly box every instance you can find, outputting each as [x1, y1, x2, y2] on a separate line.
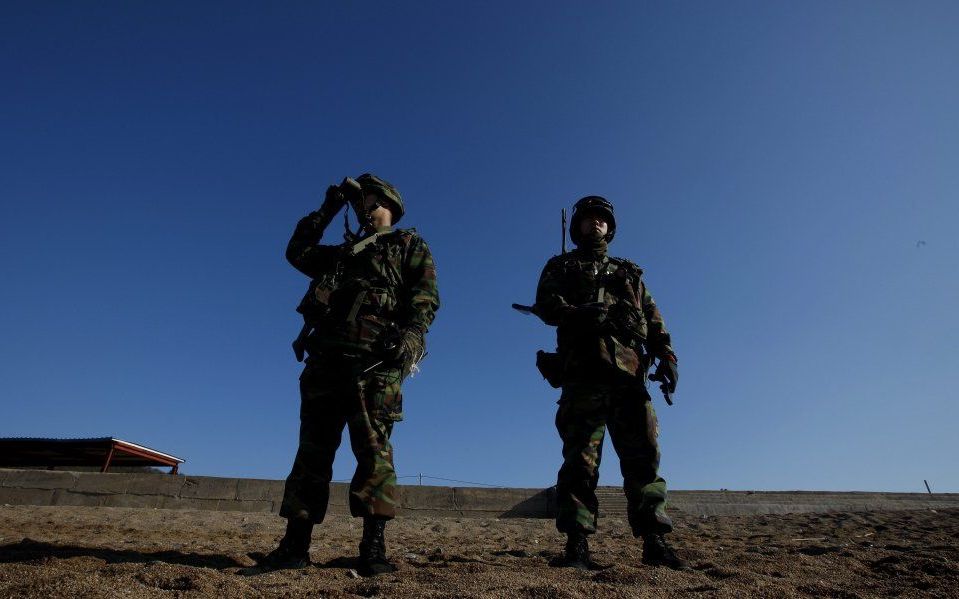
[286, 208, 440, 353]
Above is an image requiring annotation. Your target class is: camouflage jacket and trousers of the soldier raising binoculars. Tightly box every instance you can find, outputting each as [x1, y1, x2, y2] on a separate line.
[280, 198, 439, 523]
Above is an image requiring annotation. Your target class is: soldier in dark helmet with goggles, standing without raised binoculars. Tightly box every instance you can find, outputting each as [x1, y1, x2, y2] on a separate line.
[535, 196, 686, 569]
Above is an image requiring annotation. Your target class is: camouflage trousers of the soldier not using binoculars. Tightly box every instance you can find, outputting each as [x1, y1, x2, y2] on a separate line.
[556, 381, 672, 537]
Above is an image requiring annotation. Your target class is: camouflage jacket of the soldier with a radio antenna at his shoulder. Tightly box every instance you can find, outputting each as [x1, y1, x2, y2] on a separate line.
[536, 249, 673, 377]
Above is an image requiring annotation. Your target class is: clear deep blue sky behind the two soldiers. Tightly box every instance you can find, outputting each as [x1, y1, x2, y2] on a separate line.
[0, 1, 959, 492]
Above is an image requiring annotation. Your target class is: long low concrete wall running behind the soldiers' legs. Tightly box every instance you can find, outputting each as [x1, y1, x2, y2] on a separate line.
[0, 469, 959, 518]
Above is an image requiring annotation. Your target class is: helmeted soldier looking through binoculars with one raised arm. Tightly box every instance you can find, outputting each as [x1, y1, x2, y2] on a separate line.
[250, 174, 439, 575]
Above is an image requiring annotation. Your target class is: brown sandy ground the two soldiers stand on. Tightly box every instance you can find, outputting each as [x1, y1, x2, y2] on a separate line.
[0, 506, 959, 598]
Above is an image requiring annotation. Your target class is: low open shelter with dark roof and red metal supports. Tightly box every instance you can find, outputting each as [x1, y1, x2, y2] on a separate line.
[0, 437, 185, 474]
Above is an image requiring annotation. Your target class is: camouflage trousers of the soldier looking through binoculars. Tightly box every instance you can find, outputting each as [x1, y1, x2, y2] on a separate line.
[280, 357, 403, 524]
